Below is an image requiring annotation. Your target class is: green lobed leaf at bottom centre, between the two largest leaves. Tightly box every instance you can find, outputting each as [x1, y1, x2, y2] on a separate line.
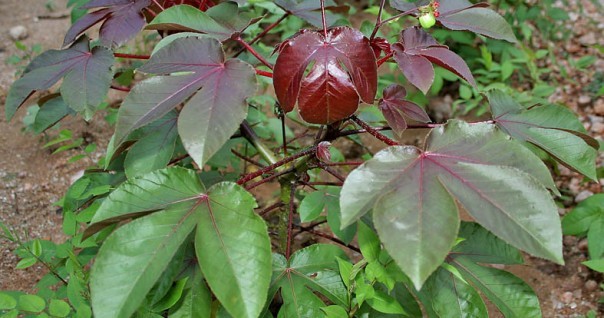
[269, 244, 348, 318]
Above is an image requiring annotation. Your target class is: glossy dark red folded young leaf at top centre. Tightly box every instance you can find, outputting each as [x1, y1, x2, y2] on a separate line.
[273, 27, 377, 124]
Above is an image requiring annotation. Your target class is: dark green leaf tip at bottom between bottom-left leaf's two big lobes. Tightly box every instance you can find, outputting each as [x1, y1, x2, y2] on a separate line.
[169, 273, 212, 318]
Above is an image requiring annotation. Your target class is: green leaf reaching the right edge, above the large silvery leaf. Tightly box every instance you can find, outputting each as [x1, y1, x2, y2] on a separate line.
[487, 90, 599, 180]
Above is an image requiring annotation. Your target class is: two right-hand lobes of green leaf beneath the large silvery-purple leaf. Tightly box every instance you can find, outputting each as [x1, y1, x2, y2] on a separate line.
[448, 222, 541, 318]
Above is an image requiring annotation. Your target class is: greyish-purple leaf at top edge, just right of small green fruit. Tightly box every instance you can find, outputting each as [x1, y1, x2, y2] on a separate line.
[390, 0, 517, 43]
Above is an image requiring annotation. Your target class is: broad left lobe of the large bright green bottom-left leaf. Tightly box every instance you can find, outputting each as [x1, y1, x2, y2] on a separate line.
[90, 202, 200, 318]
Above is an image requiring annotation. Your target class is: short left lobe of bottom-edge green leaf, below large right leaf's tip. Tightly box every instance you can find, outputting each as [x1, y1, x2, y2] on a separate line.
[421, 268, 489, 318]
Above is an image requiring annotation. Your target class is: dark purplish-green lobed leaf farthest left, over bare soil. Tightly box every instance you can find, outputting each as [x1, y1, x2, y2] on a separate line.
[5, 37, 114, 119]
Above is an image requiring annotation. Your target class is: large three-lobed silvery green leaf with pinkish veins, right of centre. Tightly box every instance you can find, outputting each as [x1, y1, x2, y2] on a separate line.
[340, 121, 563, 288]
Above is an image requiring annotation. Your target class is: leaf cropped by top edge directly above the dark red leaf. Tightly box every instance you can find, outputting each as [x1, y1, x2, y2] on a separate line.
[275, 0, 337, 27]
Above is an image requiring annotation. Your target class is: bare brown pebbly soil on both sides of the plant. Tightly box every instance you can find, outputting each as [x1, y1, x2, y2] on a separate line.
[0, 0, 604, 317]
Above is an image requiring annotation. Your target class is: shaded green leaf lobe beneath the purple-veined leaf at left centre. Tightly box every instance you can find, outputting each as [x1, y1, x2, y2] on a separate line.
[124, 113, 178, 178]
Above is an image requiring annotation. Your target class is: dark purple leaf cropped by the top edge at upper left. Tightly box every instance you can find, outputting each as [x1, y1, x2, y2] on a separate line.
[63, 0, 151, 47]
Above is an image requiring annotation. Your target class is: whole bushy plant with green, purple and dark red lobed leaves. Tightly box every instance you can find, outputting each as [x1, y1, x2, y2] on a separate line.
[6, 0, 597, 318]
